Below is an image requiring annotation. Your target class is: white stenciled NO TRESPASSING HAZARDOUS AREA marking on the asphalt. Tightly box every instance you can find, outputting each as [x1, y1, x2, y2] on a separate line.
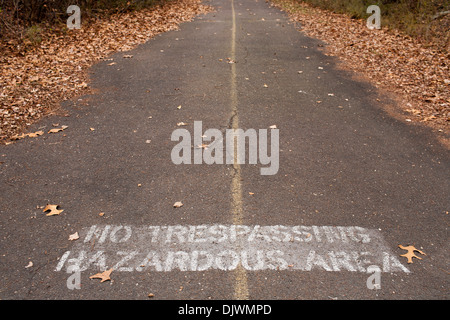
[55, 224, 410, 274]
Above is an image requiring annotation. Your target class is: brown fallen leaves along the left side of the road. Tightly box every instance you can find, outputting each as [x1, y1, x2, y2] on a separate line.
[0, 0, 212, 144]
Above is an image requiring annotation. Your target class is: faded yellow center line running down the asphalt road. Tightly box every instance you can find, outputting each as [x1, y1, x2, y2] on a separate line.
[230, 0, 249, 300]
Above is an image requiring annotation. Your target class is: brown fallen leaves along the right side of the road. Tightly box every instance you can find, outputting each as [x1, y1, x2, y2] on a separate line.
[271, 0, 450, 133]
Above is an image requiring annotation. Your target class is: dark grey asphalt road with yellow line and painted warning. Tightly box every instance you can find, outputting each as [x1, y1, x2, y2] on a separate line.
[0, 0, 450, 300]
